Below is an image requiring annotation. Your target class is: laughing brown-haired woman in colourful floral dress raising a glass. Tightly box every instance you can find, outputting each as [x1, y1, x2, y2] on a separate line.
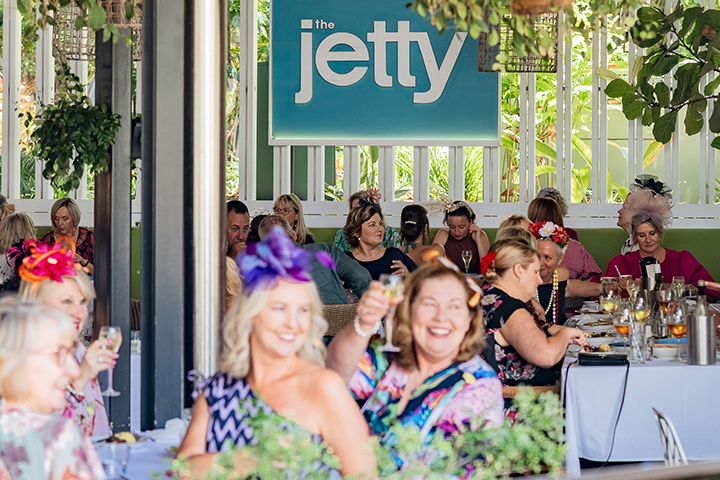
[327, 257, 503, 441]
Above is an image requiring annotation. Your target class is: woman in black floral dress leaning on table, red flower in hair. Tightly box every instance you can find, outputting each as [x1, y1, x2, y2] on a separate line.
[482, 237, 587, 398]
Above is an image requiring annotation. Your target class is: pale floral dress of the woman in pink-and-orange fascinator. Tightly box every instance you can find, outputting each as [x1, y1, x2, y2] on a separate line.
[62, 342, 112, 437]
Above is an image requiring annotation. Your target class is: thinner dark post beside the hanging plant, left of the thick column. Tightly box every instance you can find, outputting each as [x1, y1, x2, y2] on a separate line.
[95, 30, 132, 432]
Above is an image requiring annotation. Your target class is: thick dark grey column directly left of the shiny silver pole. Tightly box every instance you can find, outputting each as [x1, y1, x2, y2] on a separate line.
[140, 0, 193, 430]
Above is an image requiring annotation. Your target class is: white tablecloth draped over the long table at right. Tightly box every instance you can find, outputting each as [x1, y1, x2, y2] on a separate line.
[562, 358, 720, 477]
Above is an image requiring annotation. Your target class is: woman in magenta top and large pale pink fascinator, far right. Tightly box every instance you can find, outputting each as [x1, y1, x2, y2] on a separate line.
[605, 189, 713, 296]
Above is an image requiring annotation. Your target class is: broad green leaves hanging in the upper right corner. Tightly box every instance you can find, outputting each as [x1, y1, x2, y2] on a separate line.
[598, 2, 720, 149]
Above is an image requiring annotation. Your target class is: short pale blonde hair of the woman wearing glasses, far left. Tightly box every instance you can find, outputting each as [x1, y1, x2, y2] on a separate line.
[0, 301, 77, 399]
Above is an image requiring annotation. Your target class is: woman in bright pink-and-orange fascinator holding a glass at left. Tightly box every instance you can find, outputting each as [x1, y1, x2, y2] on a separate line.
[18, 237, 111, 437]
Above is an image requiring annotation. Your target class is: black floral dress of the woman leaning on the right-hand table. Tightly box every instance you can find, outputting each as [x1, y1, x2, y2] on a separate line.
[482, 286, 555, 386]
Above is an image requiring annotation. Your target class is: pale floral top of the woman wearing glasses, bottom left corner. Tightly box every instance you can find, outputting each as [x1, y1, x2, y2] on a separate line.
[0, 401, 105, 480]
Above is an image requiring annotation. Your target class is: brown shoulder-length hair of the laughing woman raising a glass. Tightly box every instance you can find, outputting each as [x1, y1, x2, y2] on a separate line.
[393, 265, 485, 370]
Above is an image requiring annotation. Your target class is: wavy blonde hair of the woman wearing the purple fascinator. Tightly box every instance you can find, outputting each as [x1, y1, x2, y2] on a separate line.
[220, 282, 327, 378]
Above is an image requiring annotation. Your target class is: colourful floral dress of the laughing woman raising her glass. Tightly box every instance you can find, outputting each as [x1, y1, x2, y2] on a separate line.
[348, 342, 503, 437]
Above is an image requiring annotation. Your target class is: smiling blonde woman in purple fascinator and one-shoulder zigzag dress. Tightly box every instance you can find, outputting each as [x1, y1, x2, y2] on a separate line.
[178, 227, 375, 478]
